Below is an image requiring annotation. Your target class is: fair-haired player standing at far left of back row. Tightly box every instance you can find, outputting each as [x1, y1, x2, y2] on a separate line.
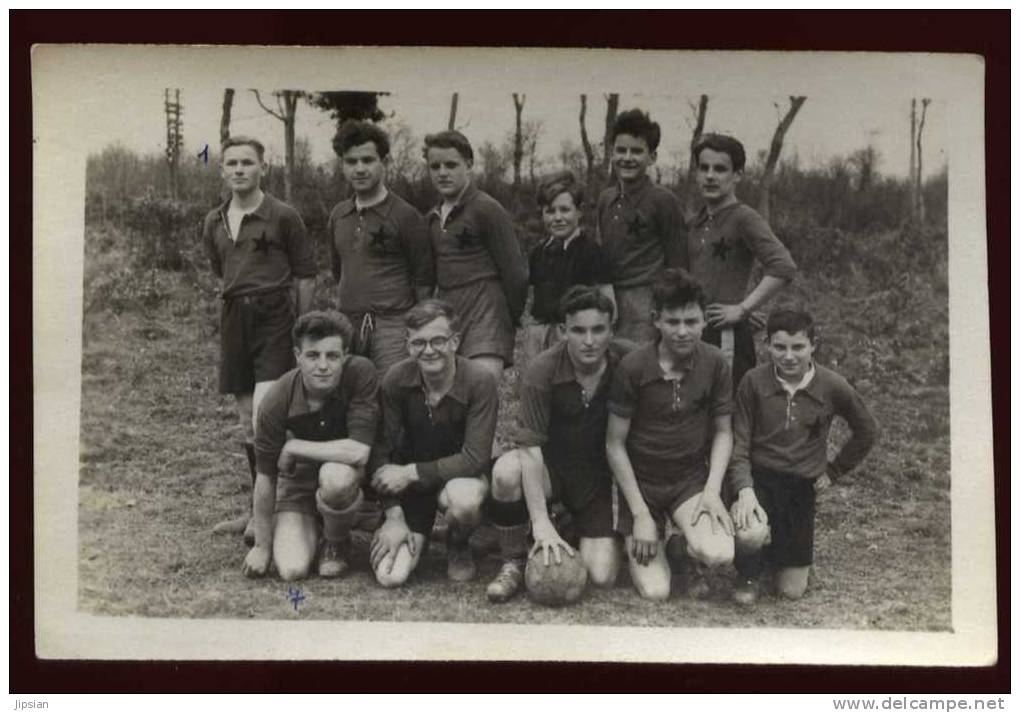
[202, 136, 316, 544]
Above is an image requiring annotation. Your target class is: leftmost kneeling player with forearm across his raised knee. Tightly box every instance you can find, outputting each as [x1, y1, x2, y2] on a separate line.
[244, 311, 378, 580]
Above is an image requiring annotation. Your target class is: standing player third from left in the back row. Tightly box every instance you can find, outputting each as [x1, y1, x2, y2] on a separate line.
[425, 132, 527, 380]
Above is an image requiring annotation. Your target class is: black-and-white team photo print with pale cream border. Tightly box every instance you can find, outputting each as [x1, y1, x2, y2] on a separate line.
[34, 47, 995, 665]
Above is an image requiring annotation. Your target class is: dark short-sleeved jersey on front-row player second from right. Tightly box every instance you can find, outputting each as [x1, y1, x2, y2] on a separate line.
[609, 342, 733, 485]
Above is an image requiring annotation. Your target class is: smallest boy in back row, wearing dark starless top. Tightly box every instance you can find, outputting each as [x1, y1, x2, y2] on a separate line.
[521, 170, 615, 373]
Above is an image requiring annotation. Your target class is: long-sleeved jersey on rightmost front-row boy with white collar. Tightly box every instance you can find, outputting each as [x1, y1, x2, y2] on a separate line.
[727, 362, 878, 493]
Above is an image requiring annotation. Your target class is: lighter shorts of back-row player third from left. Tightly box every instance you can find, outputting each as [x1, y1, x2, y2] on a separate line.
[438, 279, 514, 367]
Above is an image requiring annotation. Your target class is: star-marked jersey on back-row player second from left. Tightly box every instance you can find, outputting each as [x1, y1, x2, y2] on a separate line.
[327, 191, 436, 314]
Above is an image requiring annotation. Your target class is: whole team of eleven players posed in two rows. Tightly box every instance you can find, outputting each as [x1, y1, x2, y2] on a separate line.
[203, 110, 876, 604]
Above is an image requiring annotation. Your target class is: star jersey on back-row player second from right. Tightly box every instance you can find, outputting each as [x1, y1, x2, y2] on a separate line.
[596, 175, 686, 288]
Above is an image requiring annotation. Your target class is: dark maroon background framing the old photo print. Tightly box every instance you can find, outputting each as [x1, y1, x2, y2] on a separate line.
[9, 10, 1011, 694]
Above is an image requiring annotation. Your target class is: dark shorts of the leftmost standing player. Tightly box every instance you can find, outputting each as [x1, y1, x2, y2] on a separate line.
[219, 290, 295, 394]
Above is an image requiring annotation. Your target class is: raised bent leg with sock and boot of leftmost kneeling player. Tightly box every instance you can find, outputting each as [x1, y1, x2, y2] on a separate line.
[315, 463, 364, 577]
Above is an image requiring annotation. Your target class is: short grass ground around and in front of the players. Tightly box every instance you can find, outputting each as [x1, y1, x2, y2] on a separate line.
[78, 223, 951, 630]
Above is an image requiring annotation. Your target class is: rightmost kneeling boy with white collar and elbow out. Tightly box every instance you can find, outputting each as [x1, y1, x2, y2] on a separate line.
[728, 310, 878, 605]
